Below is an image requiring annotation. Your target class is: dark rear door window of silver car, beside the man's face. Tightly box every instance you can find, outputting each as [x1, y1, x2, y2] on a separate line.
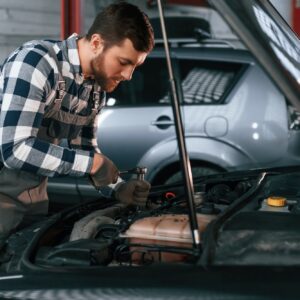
[107, 57, 168, 107]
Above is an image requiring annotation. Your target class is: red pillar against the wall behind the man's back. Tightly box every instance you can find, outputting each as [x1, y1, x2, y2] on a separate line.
[60, 0, 83, 39]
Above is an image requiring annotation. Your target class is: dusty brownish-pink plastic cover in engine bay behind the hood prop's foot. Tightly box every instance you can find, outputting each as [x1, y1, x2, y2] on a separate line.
[122, 214, 216, 262]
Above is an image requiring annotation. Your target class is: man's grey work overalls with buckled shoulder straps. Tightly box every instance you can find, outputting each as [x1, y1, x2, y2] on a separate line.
[0, 42, 104, 249]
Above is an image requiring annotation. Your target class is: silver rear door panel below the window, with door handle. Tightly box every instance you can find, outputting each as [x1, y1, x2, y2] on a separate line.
[98, 107, 175, 170]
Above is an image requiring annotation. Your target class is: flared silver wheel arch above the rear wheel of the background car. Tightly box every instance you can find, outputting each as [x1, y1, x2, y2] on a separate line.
[138, 137, 255, 181]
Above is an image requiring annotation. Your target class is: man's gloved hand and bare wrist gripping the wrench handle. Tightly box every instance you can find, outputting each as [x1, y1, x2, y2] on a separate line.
[90, 153, 119, 189]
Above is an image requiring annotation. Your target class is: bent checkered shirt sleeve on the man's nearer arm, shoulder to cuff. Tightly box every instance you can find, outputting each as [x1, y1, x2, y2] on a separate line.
[0, 47, 93, 177]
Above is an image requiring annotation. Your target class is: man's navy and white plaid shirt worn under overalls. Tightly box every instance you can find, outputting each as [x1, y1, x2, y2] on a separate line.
[0, 34, 105, 177]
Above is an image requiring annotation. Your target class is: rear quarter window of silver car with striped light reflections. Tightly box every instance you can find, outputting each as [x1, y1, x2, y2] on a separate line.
[175, 59, 242, 104]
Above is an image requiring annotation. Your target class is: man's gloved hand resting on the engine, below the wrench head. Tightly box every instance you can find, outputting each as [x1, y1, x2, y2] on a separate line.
[115, 179, 151, 206]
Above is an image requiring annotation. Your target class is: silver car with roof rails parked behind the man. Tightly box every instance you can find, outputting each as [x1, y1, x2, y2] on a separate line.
[49, 37, 300, 199]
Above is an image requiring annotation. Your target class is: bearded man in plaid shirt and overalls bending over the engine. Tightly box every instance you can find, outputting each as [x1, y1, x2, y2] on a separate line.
[0, 2, 154, 247]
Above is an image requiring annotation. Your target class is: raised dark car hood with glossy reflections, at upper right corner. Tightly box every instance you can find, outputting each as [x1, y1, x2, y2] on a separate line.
[209, 0, 300, 110]
